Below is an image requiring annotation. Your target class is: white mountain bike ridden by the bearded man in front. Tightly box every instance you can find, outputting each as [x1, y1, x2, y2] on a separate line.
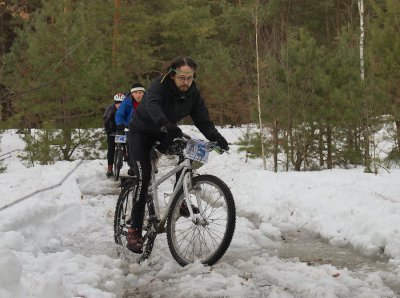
[114, 136, 236, 266]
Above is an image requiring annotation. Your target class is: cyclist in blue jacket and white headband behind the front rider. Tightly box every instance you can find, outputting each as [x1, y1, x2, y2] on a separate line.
[115, 83, 145, 176]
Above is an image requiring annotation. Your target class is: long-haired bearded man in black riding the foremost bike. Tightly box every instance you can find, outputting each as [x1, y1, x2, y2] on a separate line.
[127, 57, 229, 253]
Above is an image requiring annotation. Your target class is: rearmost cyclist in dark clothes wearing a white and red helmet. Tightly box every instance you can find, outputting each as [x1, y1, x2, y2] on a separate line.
[103, 93, 125, 177]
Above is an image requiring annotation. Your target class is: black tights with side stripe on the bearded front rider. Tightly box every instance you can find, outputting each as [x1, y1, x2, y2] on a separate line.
[128, 131, 184, 231]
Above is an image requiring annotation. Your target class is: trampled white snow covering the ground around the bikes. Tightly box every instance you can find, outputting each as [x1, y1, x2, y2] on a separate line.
[0, 126, 400, 298]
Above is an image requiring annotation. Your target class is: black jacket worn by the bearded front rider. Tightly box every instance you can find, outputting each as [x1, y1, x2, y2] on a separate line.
[130, 76, 219, 141]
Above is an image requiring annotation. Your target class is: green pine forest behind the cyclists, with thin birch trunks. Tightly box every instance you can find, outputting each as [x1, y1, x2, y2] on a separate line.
[0, 0, 400, 172]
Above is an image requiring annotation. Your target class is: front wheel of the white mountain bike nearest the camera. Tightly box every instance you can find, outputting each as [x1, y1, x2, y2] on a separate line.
[167, 175, 236, 266]
